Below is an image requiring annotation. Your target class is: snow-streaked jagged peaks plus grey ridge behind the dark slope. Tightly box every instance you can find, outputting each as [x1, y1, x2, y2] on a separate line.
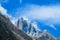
[14, 17, 60, 40]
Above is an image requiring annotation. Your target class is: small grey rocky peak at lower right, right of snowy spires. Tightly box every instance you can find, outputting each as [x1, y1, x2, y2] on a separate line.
[37, 30, 57, 40]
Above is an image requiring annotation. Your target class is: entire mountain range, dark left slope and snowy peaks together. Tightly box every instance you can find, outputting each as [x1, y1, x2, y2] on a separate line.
[0, 12, 60, 40]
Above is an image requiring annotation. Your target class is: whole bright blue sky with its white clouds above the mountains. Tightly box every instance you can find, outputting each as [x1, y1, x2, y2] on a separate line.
[0, 0, 60, 37]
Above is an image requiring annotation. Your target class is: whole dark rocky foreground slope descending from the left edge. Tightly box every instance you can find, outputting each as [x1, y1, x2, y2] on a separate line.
[0, 12, 33, 40]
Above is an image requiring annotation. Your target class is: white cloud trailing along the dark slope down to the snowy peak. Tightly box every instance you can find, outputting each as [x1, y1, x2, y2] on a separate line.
[0, 4, 17, 24]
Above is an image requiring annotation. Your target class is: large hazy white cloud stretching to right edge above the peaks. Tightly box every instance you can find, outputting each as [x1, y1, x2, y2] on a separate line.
[16, 5, 60, 23]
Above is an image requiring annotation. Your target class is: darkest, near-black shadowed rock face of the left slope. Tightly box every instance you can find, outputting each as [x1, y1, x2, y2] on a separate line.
[0, 14, 18, 40]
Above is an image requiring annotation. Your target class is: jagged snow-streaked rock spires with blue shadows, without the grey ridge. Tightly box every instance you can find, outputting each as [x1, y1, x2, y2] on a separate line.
[15, 17, 40, 37]
